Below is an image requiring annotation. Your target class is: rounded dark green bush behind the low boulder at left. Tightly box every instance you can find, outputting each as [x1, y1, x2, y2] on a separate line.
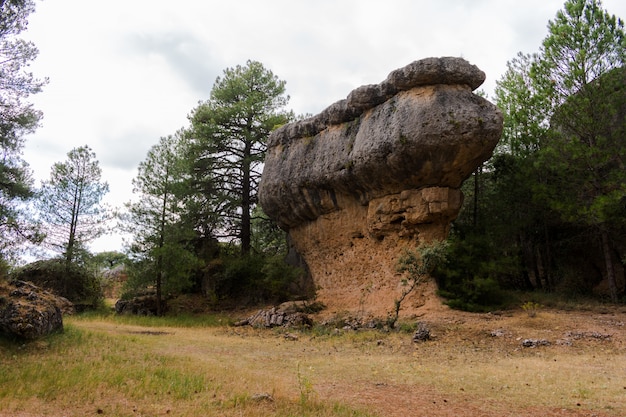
[10, 258, 103, 310]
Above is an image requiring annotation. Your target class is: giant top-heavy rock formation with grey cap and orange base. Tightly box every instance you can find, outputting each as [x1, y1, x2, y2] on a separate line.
[259, 58, 502, 315]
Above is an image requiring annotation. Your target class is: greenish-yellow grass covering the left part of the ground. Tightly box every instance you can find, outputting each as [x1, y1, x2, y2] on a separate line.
[0, 313, 369, 417]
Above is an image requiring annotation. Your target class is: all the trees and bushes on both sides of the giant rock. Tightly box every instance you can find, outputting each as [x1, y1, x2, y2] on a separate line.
[0, 0, 626, 314]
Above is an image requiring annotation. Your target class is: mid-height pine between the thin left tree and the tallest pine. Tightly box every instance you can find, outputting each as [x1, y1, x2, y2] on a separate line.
[125, 131, 198, 315]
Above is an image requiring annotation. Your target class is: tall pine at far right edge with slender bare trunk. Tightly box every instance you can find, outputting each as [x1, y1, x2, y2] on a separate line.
[531, 0, 626, 301]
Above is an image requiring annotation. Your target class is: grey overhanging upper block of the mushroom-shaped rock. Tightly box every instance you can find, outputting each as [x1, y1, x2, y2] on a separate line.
[259, 57, 502, 230]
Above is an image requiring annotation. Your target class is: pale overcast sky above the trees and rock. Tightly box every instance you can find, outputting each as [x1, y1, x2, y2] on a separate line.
[23, 0, 626, 251]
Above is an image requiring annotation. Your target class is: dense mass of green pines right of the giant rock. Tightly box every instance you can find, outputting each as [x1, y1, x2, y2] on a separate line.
[472, 0, 626, 300]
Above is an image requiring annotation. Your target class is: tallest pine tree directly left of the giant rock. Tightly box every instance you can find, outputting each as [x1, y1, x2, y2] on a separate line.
[189, 61, 293, 254]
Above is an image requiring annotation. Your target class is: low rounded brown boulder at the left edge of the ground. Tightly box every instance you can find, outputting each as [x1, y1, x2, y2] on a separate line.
[0, 281, 73, 340]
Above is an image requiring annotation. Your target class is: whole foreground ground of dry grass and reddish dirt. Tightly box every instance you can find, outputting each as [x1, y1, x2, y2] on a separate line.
[0, 309, 626, 417]
